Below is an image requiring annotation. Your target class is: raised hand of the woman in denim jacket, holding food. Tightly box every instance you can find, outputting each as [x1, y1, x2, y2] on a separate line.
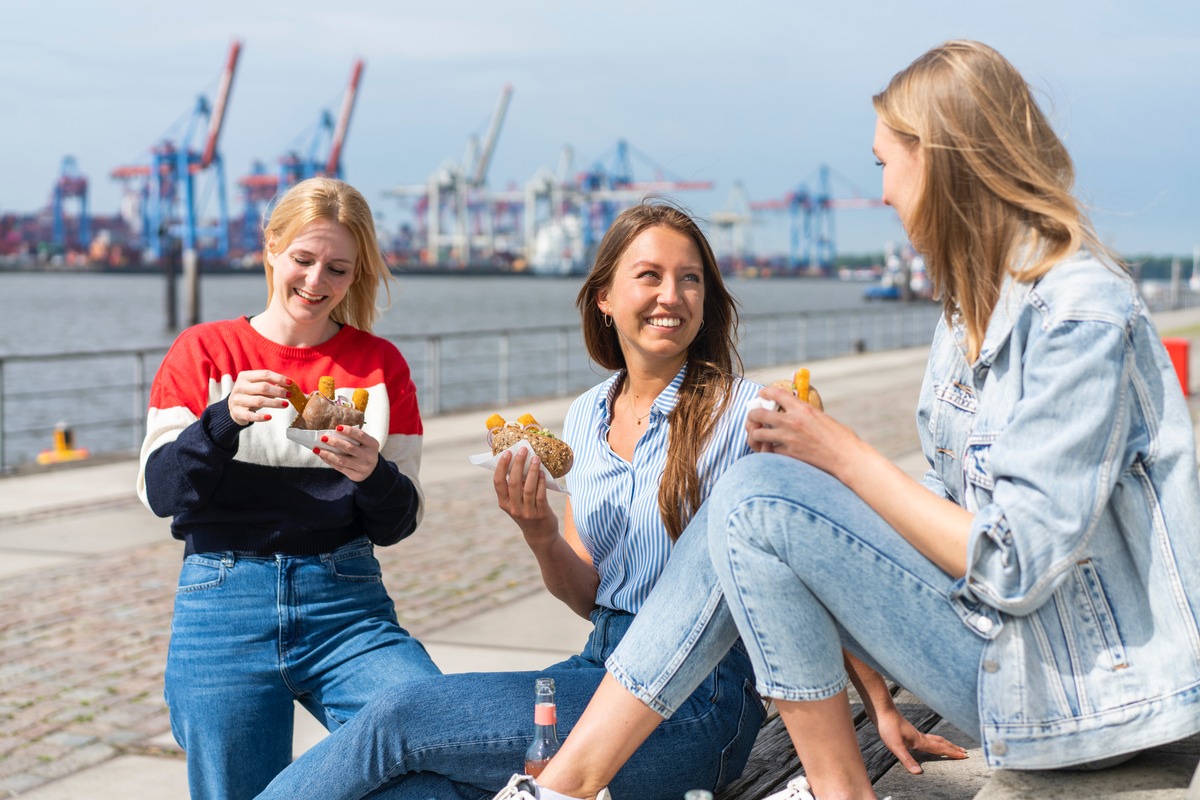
[746, 386, 863, 476]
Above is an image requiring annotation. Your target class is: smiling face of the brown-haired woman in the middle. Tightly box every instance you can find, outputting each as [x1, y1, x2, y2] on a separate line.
[596, 225, 704, 377]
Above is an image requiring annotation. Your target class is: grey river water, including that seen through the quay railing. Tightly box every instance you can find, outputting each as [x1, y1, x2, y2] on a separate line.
[0, 272, 916, 471]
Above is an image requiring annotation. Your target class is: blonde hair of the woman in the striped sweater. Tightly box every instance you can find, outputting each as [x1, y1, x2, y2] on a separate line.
[263, 178, 391, 332]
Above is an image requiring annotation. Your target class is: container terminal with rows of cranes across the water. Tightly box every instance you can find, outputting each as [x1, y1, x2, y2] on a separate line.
[0, 40, 902, 276]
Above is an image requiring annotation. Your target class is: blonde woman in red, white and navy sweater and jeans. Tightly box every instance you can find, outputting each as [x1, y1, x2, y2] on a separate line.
[138, 178, 439, 800]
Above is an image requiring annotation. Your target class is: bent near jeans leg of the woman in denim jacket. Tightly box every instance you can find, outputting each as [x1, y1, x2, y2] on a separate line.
[709, 453, 988, 736]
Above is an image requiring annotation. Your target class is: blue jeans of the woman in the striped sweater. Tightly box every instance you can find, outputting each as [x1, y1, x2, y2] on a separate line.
[166, 539, 439, 800]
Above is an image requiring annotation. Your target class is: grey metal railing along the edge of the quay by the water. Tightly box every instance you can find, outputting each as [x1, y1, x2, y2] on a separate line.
[0, 287, 1200, 474]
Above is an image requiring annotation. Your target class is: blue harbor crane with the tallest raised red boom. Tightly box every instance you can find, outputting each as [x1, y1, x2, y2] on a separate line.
[112, 40, 241, 261]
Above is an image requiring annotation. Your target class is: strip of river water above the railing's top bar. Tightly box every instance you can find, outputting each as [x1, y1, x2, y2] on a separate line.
[0, 272, 863, 356]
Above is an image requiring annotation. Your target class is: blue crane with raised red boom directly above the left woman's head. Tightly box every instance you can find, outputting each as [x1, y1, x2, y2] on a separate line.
[238, 59, 365, 251]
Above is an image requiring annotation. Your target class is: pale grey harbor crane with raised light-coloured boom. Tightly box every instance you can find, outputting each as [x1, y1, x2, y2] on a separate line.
[388, 84, 521, 266]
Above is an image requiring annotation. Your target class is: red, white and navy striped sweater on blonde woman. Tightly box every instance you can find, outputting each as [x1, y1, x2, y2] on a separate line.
[138, 317, 422, 555]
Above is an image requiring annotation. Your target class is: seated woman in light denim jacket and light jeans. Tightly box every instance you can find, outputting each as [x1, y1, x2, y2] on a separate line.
[496, 42, 1200, 800]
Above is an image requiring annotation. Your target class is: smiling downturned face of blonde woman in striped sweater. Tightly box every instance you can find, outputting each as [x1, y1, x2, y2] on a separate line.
[265, 219, 359, 341]
